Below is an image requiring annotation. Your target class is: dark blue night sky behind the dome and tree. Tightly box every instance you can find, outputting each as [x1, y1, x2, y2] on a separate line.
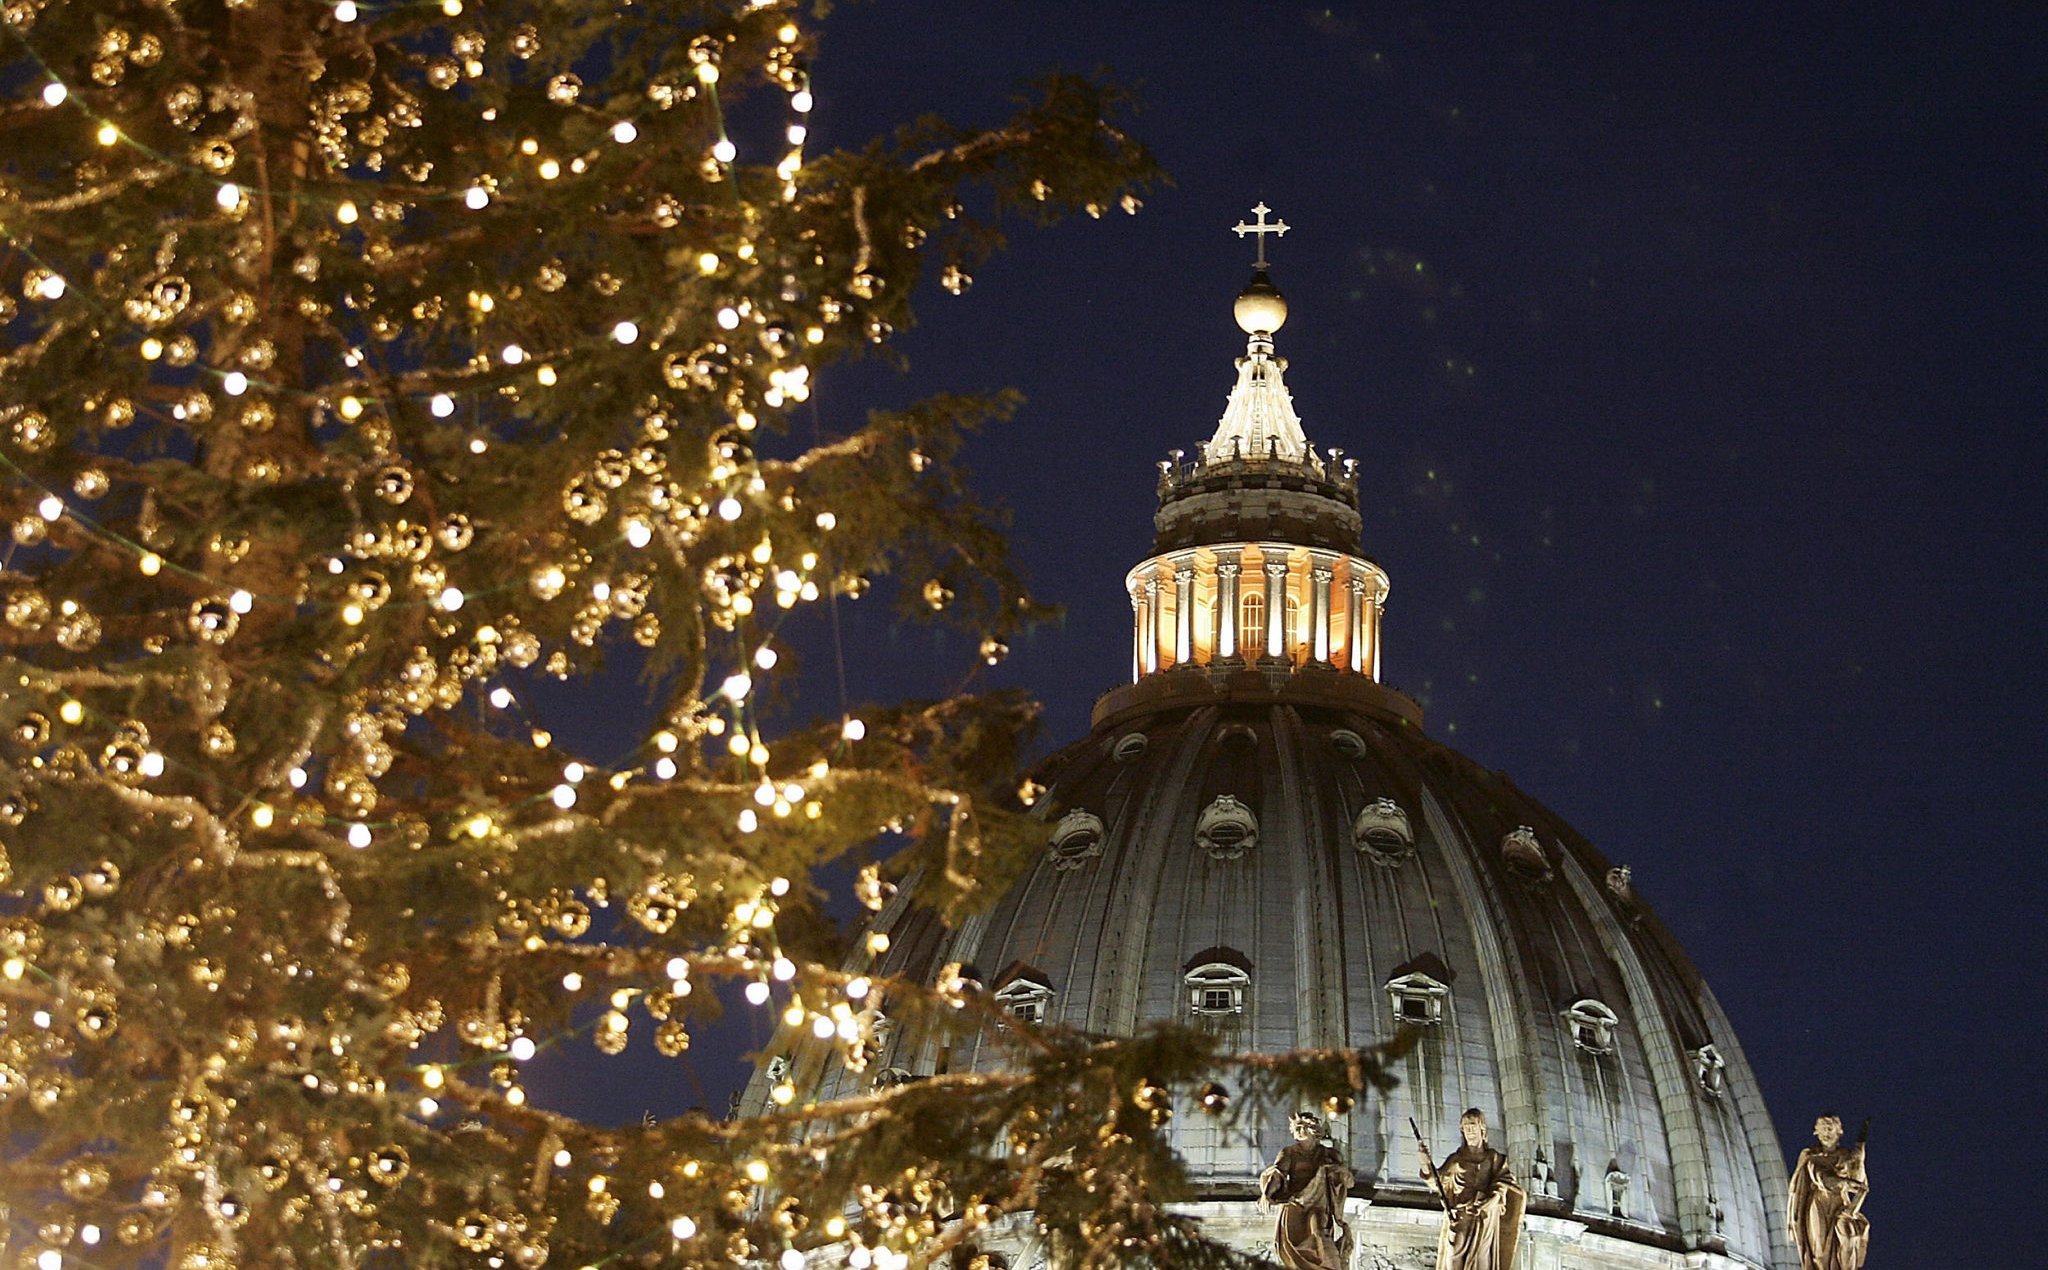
[537, 0, 2048, 1268]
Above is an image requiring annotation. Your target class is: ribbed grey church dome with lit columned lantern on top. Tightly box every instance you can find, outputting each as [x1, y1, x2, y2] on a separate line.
[754, 223, 1794, 1270]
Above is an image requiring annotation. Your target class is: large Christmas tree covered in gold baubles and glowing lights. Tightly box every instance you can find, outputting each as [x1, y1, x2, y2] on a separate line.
[0, 0, 1376, 1270]
